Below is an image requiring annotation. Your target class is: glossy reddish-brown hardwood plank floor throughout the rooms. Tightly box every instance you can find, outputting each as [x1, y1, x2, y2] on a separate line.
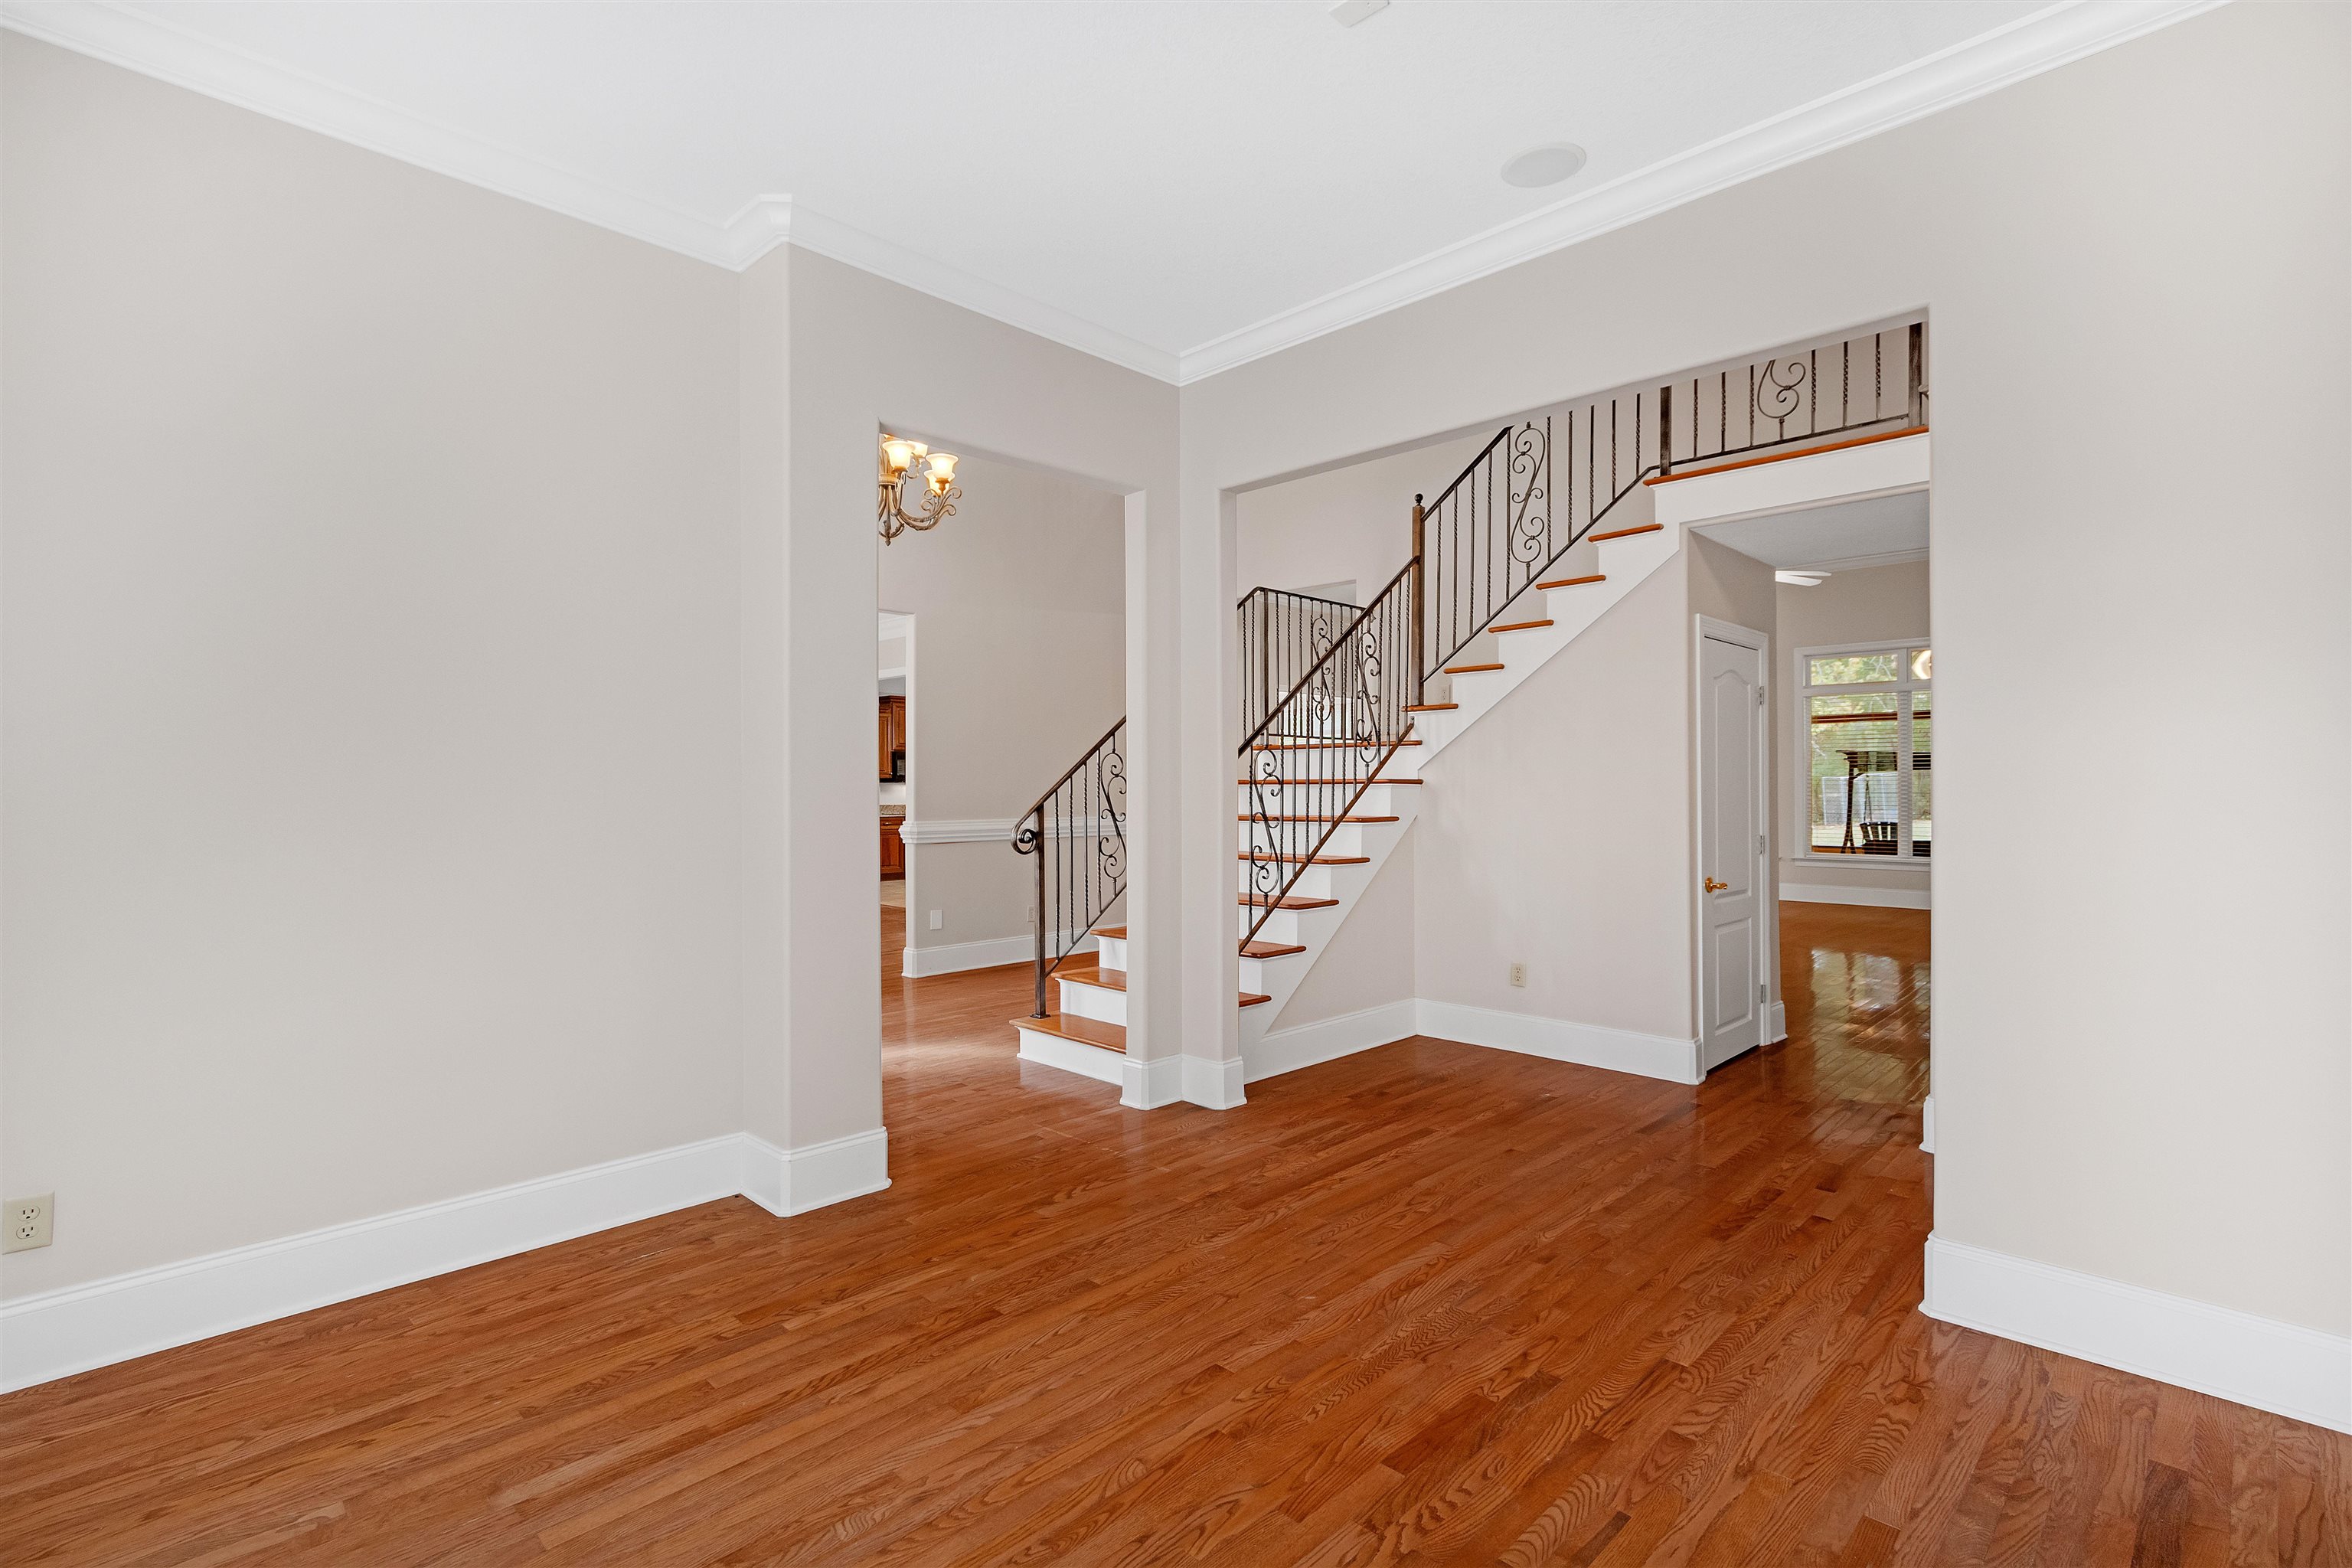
[0, 905, 2352, 1568]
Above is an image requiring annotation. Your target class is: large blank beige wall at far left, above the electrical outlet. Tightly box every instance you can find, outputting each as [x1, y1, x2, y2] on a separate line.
[0, 33, 743, 1298]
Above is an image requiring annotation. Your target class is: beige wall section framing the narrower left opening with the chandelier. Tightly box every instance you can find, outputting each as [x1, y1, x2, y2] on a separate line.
[762, 247, 1185, 1147]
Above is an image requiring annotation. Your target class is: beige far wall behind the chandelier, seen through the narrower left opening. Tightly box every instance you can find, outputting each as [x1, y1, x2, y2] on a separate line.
[880, 446, 1126, 947]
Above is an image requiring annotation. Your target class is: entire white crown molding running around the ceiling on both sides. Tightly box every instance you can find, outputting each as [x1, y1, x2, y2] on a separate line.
[0, 0, 2223, 386]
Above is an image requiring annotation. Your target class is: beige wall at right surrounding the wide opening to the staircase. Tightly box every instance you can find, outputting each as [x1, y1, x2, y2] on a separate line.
[1178, 5, 2352, 1333]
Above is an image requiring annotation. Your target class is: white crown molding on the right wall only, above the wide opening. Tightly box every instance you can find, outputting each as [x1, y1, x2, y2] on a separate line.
[1176, 0, 2225, 386]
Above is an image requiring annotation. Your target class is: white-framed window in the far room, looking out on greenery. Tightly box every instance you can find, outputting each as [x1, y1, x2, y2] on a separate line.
[1797, 637, 1936, 861]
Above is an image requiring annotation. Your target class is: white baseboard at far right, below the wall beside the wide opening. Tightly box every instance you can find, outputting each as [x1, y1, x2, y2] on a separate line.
[1919, 1234, 2352, 1432]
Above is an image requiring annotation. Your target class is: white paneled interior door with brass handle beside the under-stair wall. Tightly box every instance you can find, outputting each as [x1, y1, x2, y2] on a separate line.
[1698, 635, 1766, 1072]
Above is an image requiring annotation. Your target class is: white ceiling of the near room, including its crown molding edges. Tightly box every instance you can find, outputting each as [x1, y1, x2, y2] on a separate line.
[0, 0, 2211, 381]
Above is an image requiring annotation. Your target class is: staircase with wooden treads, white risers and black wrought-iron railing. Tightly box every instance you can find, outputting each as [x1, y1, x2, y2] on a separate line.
[1014, 322, 1926, 1099]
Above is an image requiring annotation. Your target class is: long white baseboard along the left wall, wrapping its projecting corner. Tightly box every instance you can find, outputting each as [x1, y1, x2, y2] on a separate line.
[0, 1129, 889, 1392]
